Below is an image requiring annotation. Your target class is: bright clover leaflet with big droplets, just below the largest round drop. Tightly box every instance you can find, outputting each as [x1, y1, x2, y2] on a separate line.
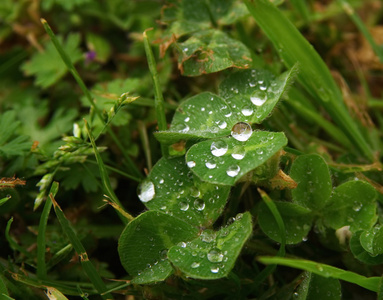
[186, 131, 287, 185]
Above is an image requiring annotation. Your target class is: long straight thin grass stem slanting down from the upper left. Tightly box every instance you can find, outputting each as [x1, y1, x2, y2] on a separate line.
[41, 19, 143, 178]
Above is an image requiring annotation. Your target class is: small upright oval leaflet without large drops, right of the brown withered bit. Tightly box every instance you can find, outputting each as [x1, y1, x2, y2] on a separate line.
[290, 154, 332, 211]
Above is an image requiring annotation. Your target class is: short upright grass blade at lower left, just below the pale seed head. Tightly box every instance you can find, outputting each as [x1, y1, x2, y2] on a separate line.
[36, 182, 59, 279]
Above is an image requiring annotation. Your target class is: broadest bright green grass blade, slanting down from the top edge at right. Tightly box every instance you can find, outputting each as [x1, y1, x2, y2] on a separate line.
[244, 0, 374, 161]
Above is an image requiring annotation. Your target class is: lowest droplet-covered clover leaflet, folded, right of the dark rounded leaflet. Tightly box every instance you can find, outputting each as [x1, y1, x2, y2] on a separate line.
[168, 212, 252, 279]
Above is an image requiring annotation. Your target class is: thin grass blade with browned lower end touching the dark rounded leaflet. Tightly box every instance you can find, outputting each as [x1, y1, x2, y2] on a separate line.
[84, 119, 134, 223]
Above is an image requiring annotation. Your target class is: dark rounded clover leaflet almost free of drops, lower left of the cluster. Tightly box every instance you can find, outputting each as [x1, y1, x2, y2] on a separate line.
[118, 211, 198, 284]
